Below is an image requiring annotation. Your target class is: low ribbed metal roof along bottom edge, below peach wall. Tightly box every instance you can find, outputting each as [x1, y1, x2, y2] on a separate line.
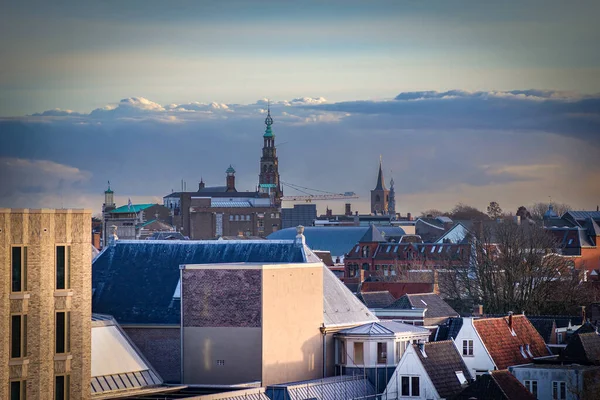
[266, 375, 375, 400]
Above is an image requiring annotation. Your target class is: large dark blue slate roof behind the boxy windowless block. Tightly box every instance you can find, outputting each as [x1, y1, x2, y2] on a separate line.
[92, 240, 304, 324]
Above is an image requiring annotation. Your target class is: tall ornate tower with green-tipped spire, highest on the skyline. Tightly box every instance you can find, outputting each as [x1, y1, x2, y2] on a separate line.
[258, 104, 283, 207]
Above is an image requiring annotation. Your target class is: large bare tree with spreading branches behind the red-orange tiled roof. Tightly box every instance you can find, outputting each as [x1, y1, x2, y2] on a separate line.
[440, 221, 581, 314]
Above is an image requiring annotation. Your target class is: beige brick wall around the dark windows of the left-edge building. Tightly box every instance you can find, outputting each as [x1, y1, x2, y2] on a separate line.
[0, 209, 91, 400]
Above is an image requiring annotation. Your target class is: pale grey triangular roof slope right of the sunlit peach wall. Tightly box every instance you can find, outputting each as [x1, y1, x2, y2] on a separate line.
[322, 264, 377, 327]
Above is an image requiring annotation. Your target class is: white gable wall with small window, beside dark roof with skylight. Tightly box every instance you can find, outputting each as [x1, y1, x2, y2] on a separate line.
[381, 346, 440, 400]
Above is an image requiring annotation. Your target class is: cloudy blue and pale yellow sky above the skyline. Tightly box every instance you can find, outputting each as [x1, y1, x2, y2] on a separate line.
[0, 0, 600, 214]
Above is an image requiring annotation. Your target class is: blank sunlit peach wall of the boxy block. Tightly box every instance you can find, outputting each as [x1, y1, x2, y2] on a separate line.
[262, 264, 323, 386]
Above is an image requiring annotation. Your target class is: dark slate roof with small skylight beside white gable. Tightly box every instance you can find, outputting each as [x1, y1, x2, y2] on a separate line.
[412, 340, 471, 398]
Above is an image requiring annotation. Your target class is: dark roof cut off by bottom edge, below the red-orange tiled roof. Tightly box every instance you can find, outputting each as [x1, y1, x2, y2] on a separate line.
[454, 370, 536, 400]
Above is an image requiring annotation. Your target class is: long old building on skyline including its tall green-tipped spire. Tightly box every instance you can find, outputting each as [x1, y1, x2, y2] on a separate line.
[162, 110, 283, 239]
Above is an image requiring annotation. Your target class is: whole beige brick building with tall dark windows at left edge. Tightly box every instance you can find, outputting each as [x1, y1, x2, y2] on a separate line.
[0, 209, 92, 400]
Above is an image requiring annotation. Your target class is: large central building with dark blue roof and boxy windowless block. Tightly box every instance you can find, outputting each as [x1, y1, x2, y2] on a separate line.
[92, 230, 377, 383]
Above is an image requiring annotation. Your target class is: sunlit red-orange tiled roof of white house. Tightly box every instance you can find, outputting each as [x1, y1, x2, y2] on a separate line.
[473, 315, 551, 369]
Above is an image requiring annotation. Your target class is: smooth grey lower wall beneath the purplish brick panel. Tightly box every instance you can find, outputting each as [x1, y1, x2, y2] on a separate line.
[183, 327, 261, 385]
